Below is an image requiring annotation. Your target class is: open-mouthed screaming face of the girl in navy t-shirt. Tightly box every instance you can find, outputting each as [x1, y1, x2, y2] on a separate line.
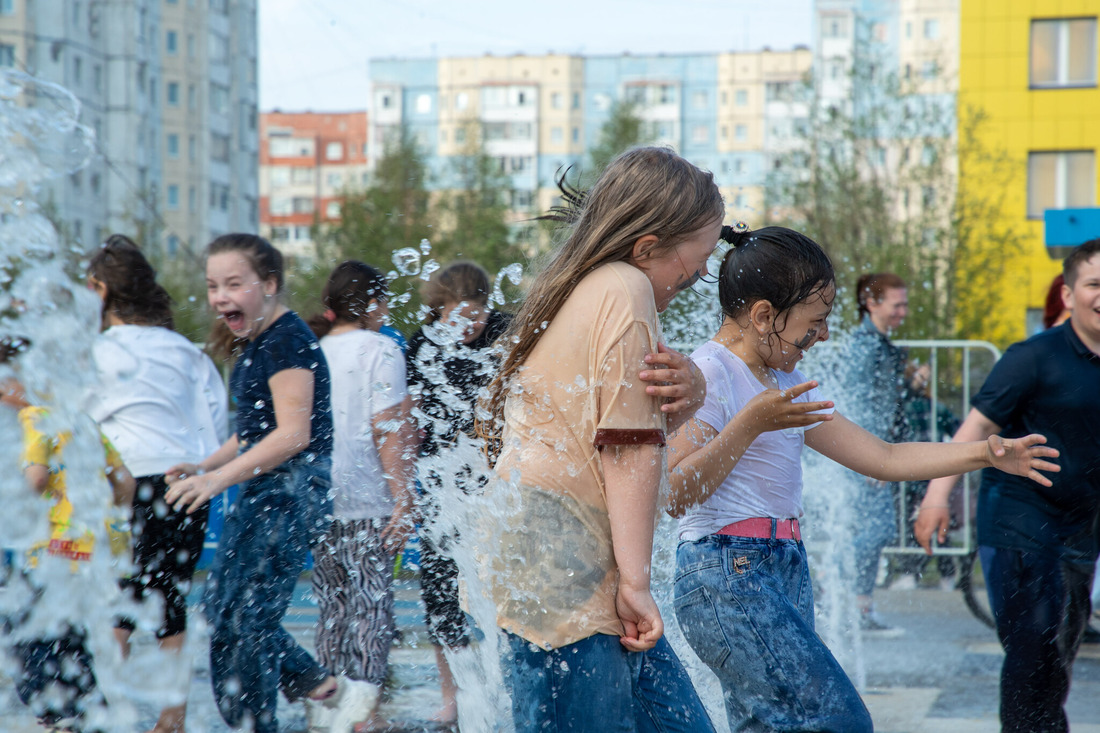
[207, 252, 278, 340]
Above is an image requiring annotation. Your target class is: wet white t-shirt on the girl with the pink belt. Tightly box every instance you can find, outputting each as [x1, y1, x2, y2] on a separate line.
[680, 341, 832, 540]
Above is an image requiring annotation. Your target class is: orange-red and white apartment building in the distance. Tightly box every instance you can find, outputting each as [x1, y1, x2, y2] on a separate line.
[260, 111, 369, 260]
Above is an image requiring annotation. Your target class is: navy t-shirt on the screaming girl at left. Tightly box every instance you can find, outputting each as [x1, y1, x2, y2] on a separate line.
[229, 311, 332, 460]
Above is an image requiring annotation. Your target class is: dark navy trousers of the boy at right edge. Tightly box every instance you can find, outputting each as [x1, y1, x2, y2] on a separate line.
[978, 546, 1093, 733]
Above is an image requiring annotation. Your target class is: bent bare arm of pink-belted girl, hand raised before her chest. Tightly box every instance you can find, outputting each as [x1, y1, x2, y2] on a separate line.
[668, 382, 833, 516]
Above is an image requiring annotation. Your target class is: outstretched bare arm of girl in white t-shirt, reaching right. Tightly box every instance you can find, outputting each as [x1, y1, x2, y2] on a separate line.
[806, 413, 1058, 486]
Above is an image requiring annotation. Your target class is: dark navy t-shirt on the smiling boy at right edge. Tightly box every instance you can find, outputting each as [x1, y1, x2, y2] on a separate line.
[970, 321, 1100, 562]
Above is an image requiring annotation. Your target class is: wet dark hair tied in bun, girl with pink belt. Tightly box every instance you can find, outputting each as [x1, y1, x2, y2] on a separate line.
[718, 227, 836, 331]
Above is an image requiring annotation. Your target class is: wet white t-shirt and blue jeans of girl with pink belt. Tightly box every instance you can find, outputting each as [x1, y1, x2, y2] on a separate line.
[674, 341, 871, 733]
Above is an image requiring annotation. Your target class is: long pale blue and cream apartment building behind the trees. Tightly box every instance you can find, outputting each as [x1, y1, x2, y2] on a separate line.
[369, 48, 812, 235]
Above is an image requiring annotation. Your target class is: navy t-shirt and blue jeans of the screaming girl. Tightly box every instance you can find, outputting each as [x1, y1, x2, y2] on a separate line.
[204, 311, 332, 733]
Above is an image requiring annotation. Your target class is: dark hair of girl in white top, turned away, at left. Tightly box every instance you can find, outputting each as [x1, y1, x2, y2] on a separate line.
[87, 234, 175, 329]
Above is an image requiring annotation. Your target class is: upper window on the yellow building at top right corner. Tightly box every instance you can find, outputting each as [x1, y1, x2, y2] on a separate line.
[1031, 18, 1097, 87]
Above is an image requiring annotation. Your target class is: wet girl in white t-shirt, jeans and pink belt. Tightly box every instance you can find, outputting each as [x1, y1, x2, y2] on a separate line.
[669, 227, 1057, 733]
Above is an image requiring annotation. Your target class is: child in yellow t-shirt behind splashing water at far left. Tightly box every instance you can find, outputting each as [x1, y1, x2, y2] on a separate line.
[7, 400, 134, 731]
